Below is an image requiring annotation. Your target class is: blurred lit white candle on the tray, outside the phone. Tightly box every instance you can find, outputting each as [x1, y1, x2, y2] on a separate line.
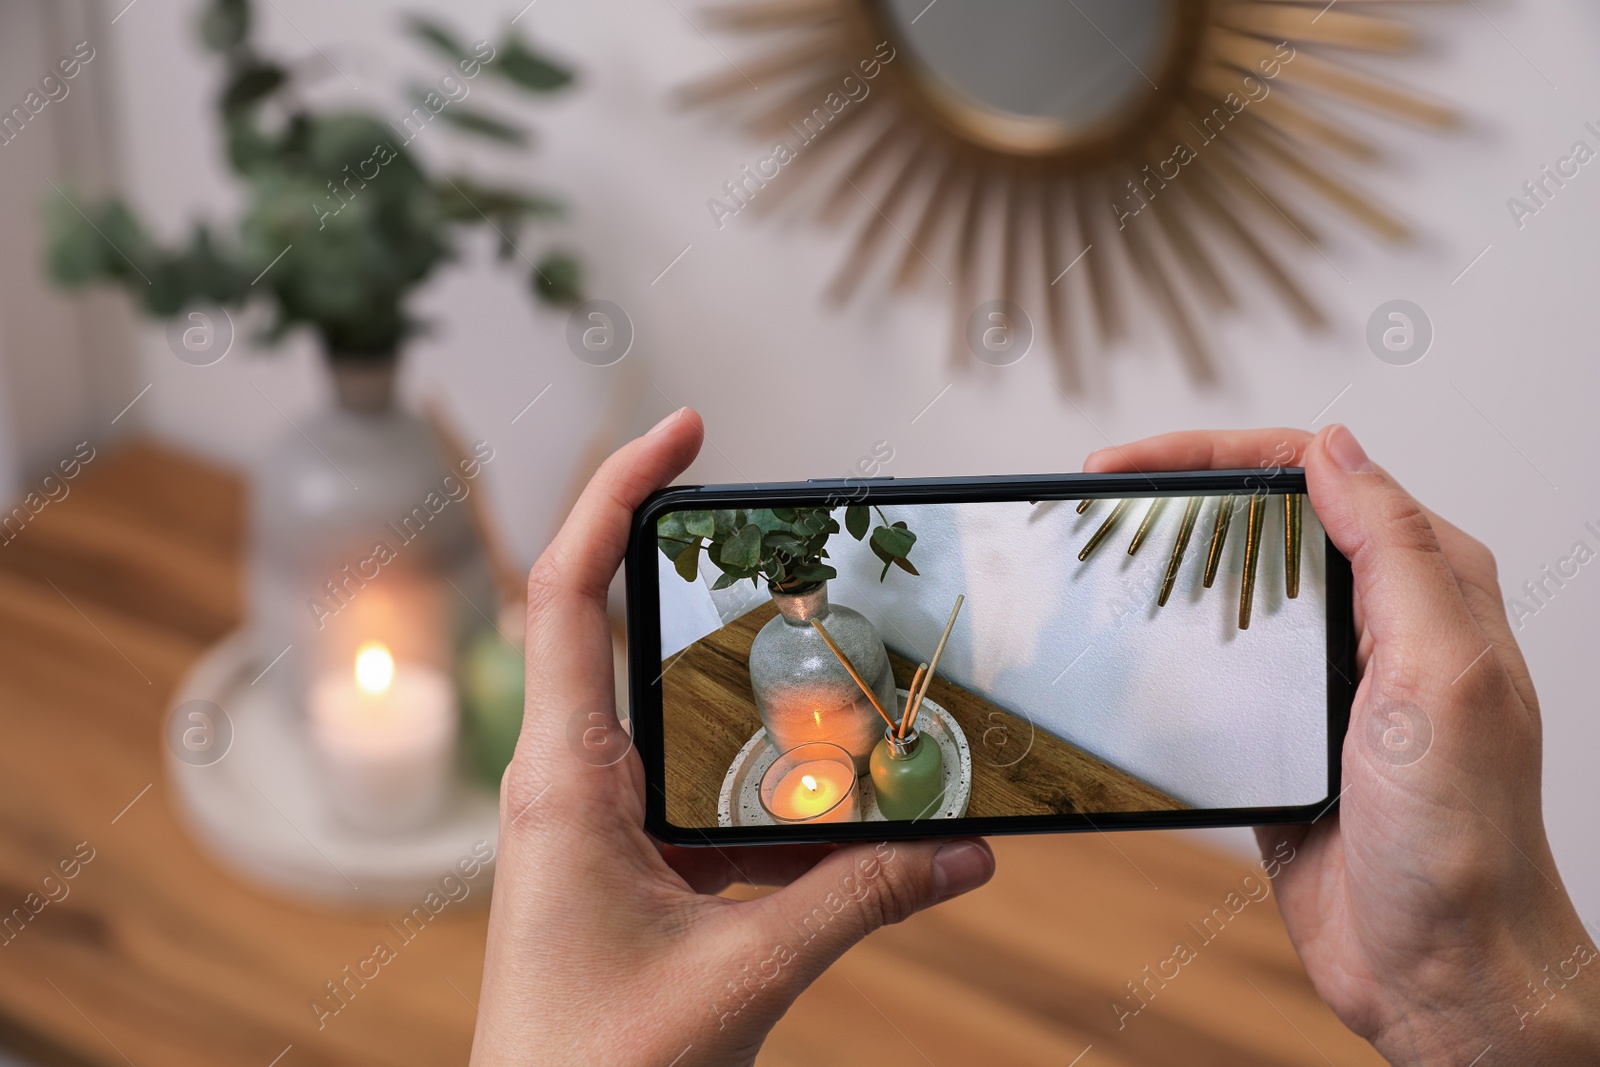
[309, 641, 456, 830]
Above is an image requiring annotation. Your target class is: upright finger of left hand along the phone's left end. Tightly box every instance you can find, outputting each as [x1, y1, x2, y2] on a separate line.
[501, 408, 704, 830]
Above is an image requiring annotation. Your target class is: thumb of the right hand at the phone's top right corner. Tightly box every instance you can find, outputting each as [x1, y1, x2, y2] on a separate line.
[1304, 426, 1486, 702]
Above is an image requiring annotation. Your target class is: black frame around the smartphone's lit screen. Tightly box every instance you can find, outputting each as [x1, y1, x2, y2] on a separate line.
[626, 467, 1357, 846]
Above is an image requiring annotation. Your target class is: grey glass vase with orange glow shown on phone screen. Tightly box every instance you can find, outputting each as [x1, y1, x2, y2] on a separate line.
[750, 582, 896, 774]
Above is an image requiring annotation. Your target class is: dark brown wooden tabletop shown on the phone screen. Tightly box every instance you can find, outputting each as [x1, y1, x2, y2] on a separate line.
[661, 601, 1184, 827]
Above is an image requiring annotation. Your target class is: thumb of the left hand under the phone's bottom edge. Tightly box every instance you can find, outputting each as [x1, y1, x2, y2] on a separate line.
[722, 838, 995, 1005]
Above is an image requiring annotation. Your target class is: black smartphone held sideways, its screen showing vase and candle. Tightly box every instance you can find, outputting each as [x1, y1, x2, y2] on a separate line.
[627, 469, 1355, 845]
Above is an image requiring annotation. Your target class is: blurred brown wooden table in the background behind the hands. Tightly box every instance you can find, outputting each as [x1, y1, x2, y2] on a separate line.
[0, 445, 1381, 1067]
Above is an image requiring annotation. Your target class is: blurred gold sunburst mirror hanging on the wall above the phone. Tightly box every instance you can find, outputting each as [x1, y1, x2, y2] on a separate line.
[682, 0, 1454, 389]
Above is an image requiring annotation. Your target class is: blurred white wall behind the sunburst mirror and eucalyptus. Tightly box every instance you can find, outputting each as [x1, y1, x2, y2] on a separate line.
[100, 0, 1600, 915]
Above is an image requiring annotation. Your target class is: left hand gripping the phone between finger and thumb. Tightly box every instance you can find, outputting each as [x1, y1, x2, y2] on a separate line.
[472, 408, 994, 1067]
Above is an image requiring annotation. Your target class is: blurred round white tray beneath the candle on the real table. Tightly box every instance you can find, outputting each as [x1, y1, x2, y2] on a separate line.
[162, 632, 499, 904]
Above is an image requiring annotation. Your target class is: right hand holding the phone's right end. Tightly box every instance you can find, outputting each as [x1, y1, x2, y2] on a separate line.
[1085, 426, 1600, 1067]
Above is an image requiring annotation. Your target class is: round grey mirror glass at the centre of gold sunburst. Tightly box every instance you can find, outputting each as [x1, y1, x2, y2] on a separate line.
[877, 0, 1179, 154]
